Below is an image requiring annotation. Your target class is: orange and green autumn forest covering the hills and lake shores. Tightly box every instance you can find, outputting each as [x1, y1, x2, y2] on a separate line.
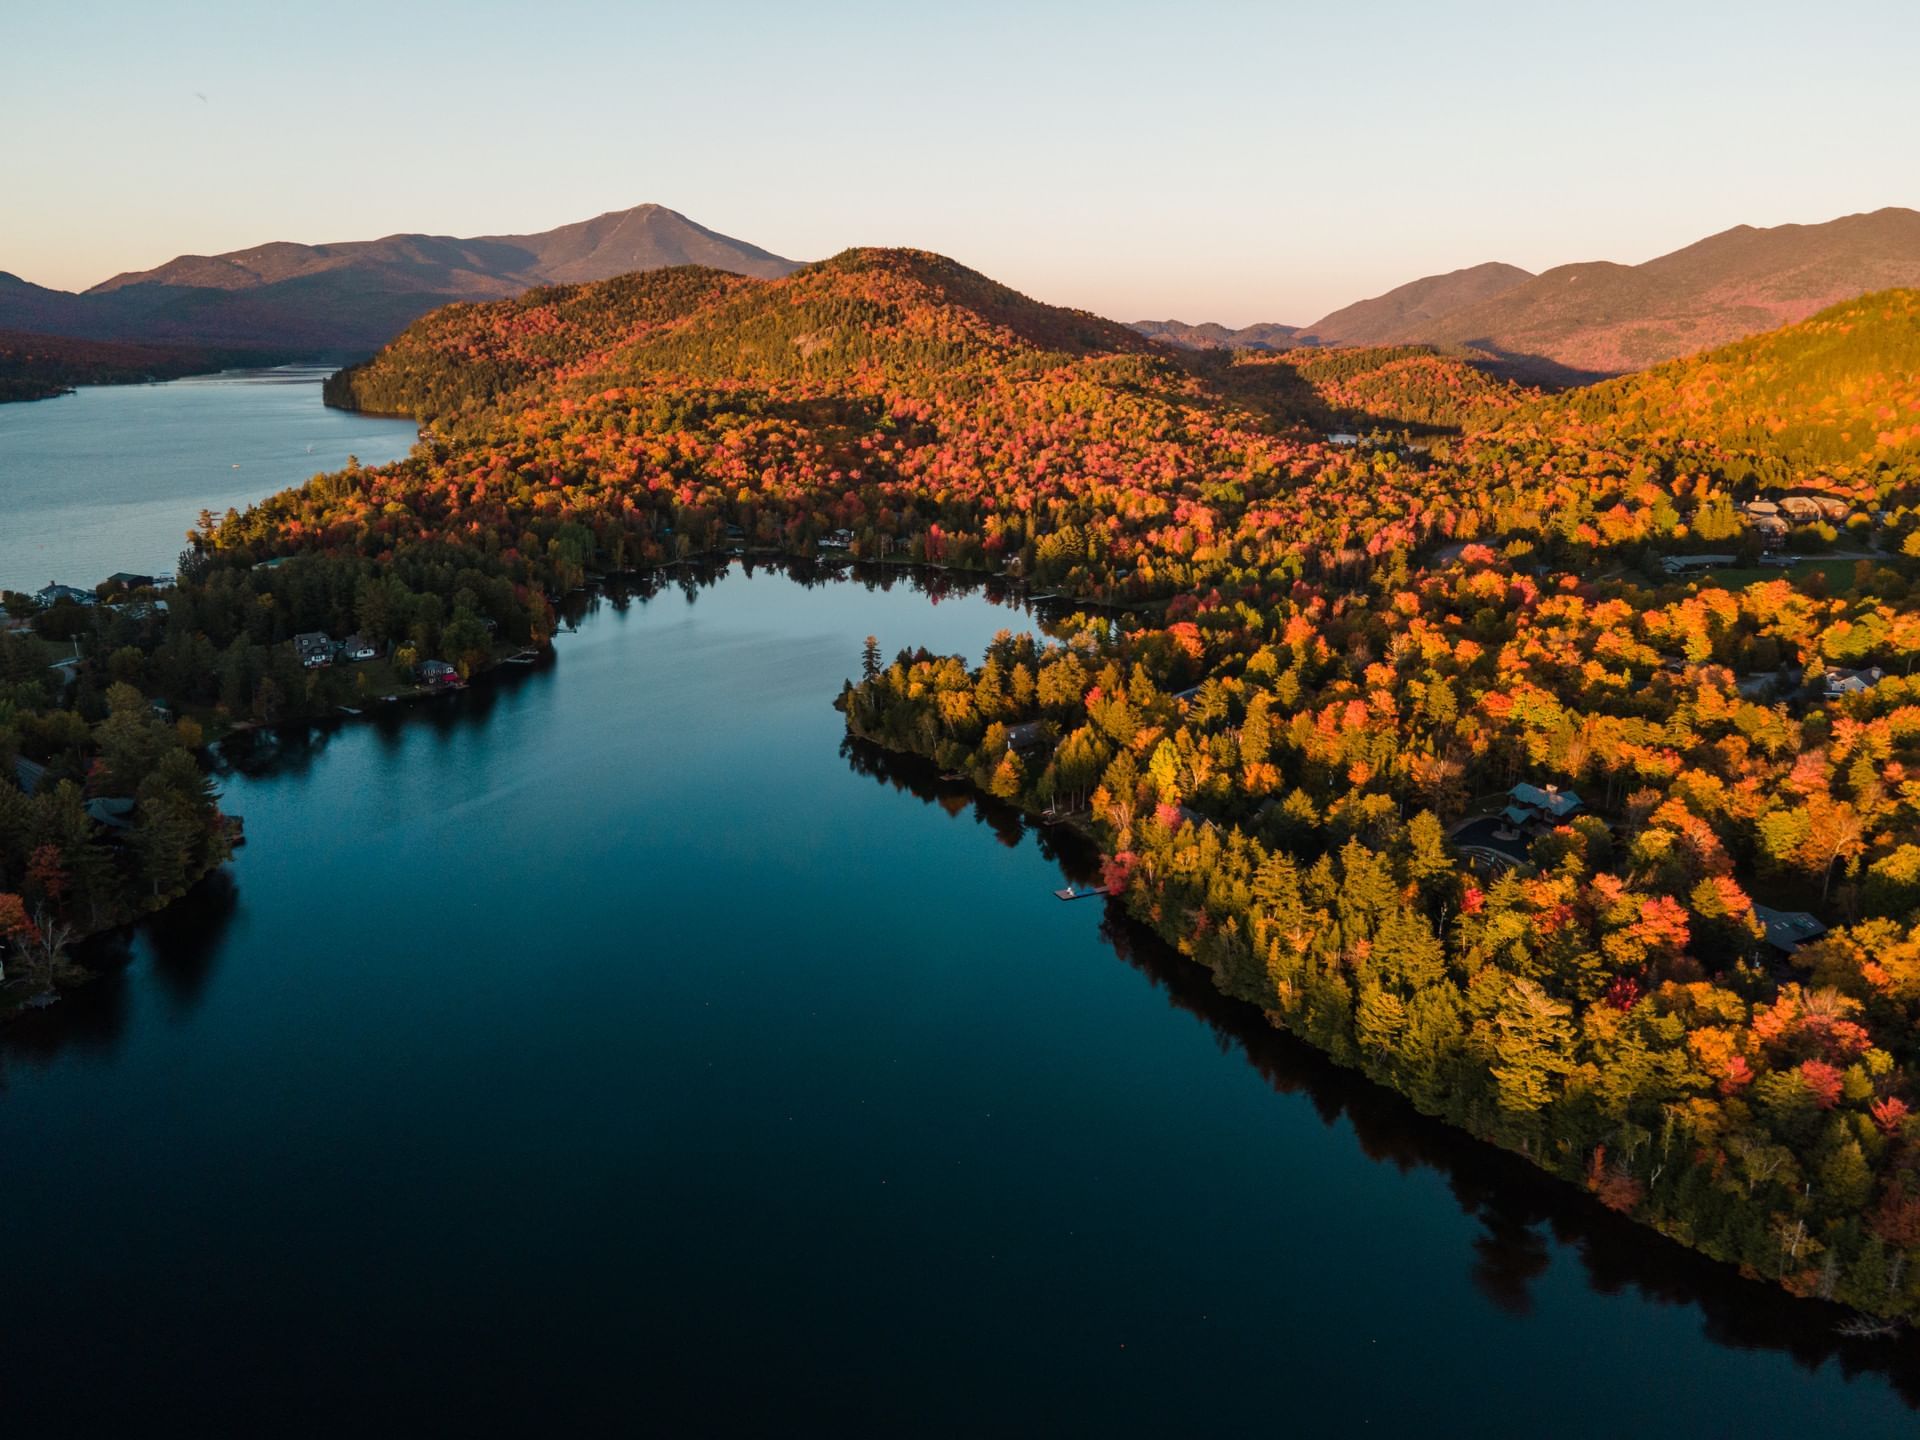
[0, 250, 1920, 1319]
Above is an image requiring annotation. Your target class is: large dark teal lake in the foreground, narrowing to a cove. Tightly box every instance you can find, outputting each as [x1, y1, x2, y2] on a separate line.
[11, 574, 1916, 1436]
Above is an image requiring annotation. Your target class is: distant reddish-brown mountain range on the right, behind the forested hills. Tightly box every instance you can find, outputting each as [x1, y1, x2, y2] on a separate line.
[1135, 207, 1920, 382]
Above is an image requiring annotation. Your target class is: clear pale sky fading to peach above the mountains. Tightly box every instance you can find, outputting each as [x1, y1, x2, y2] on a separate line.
[0, 0, 1920, 324]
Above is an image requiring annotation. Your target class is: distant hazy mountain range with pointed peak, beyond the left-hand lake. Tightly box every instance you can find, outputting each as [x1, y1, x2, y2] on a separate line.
[0, 205, 797, 359]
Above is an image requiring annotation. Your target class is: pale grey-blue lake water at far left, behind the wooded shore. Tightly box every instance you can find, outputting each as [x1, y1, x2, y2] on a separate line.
[0, 367, 417, 589]
